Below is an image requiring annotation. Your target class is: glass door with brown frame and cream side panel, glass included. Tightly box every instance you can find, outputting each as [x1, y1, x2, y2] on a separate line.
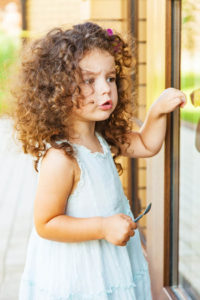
[147, 0, 200, 300]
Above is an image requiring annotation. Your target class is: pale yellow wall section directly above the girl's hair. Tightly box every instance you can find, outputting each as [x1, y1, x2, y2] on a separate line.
[26, 0, 129, 34]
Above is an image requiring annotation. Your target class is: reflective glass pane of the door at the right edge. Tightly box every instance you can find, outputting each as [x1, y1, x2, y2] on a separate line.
[178, 0, 200, 299]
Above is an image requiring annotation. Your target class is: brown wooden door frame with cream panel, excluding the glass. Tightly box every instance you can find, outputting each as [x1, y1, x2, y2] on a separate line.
[147, 0, 186, 300]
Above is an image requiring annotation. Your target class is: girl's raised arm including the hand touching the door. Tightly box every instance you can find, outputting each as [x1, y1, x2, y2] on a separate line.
[120, 88, 186, 157]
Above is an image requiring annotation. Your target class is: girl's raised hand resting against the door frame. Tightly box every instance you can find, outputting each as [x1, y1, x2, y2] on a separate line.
[151, 88, 186, 116]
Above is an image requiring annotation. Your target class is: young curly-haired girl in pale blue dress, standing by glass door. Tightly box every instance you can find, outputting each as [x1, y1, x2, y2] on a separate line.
[15, 22, 185, 300]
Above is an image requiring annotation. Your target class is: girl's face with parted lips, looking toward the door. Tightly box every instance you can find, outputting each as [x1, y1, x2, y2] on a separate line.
[70, 49, 118, 121]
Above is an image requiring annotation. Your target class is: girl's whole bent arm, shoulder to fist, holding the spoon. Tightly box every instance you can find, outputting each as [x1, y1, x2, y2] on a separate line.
[34, 148, 137, 246]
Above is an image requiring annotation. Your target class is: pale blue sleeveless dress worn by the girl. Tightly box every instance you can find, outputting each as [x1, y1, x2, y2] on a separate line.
[19, 133, 152, 300]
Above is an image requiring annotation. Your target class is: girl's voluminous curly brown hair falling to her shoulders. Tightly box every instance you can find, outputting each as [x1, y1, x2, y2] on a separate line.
[14, 22, 134, 173]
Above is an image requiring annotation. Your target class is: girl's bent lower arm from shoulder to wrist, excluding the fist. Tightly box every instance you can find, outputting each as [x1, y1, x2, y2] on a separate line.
[34, 148, 103, 242]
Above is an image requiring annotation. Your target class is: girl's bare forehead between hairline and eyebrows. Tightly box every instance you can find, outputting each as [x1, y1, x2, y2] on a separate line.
[79, 49, 115, 72]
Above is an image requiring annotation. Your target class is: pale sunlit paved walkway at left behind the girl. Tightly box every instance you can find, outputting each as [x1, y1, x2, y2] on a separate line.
[0, 119, 37, 300]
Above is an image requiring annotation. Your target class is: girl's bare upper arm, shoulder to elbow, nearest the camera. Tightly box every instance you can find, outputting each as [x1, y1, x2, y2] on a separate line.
[34, 148, 75, 232]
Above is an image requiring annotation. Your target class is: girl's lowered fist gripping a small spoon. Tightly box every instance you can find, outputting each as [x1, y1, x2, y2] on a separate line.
[102, 214, 137, 246]
